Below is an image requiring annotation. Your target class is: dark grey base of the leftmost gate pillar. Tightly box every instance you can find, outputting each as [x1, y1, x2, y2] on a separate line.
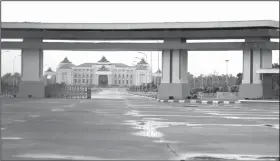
[17, 81, 45, 98]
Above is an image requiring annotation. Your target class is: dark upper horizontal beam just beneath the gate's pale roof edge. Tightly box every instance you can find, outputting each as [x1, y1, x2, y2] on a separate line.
[1, 29, 279, 40]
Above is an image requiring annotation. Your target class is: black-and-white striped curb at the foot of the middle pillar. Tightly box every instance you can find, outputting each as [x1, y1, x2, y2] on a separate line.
[157, 99, 241, 104]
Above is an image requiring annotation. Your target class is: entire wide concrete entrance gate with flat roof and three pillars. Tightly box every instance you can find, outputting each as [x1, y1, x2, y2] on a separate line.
[1, 21, 279, 99]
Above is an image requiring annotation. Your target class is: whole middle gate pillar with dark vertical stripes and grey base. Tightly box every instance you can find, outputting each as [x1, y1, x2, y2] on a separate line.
[158, 39, 191, 99]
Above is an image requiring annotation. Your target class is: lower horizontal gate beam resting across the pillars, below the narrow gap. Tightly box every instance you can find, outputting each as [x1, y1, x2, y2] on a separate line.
[2, 42, 279, 51]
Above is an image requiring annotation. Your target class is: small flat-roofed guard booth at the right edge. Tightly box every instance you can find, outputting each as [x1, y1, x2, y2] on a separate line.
[256, 68, 279, 99]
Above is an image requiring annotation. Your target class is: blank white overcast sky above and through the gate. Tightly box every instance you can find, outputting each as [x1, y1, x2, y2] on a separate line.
[1, 1, 279, 75]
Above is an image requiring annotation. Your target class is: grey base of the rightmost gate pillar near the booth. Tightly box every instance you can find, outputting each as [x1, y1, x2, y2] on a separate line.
[238, 84, 263, 99]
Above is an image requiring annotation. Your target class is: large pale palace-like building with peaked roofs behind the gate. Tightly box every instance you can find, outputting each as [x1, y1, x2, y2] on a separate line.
[45, 56, 161, 87]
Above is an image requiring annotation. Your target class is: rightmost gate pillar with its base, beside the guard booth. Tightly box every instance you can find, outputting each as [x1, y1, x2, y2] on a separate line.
[239, 38, 273, 98]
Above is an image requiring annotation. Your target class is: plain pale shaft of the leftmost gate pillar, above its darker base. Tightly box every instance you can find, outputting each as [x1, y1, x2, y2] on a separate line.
[21, 39, 43, 81]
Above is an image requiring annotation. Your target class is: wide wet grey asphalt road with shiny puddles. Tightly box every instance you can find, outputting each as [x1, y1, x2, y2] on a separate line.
[1, 89, 279, 160]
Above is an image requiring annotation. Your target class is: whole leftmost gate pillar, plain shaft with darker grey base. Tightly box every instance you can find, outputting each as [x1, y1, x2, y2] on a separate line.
[17, 39, 45, 98]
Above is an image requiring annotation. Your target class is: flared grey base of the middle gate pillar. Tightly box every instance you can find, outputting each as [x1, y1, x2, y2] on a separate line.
[158, 83, 191, 100]
